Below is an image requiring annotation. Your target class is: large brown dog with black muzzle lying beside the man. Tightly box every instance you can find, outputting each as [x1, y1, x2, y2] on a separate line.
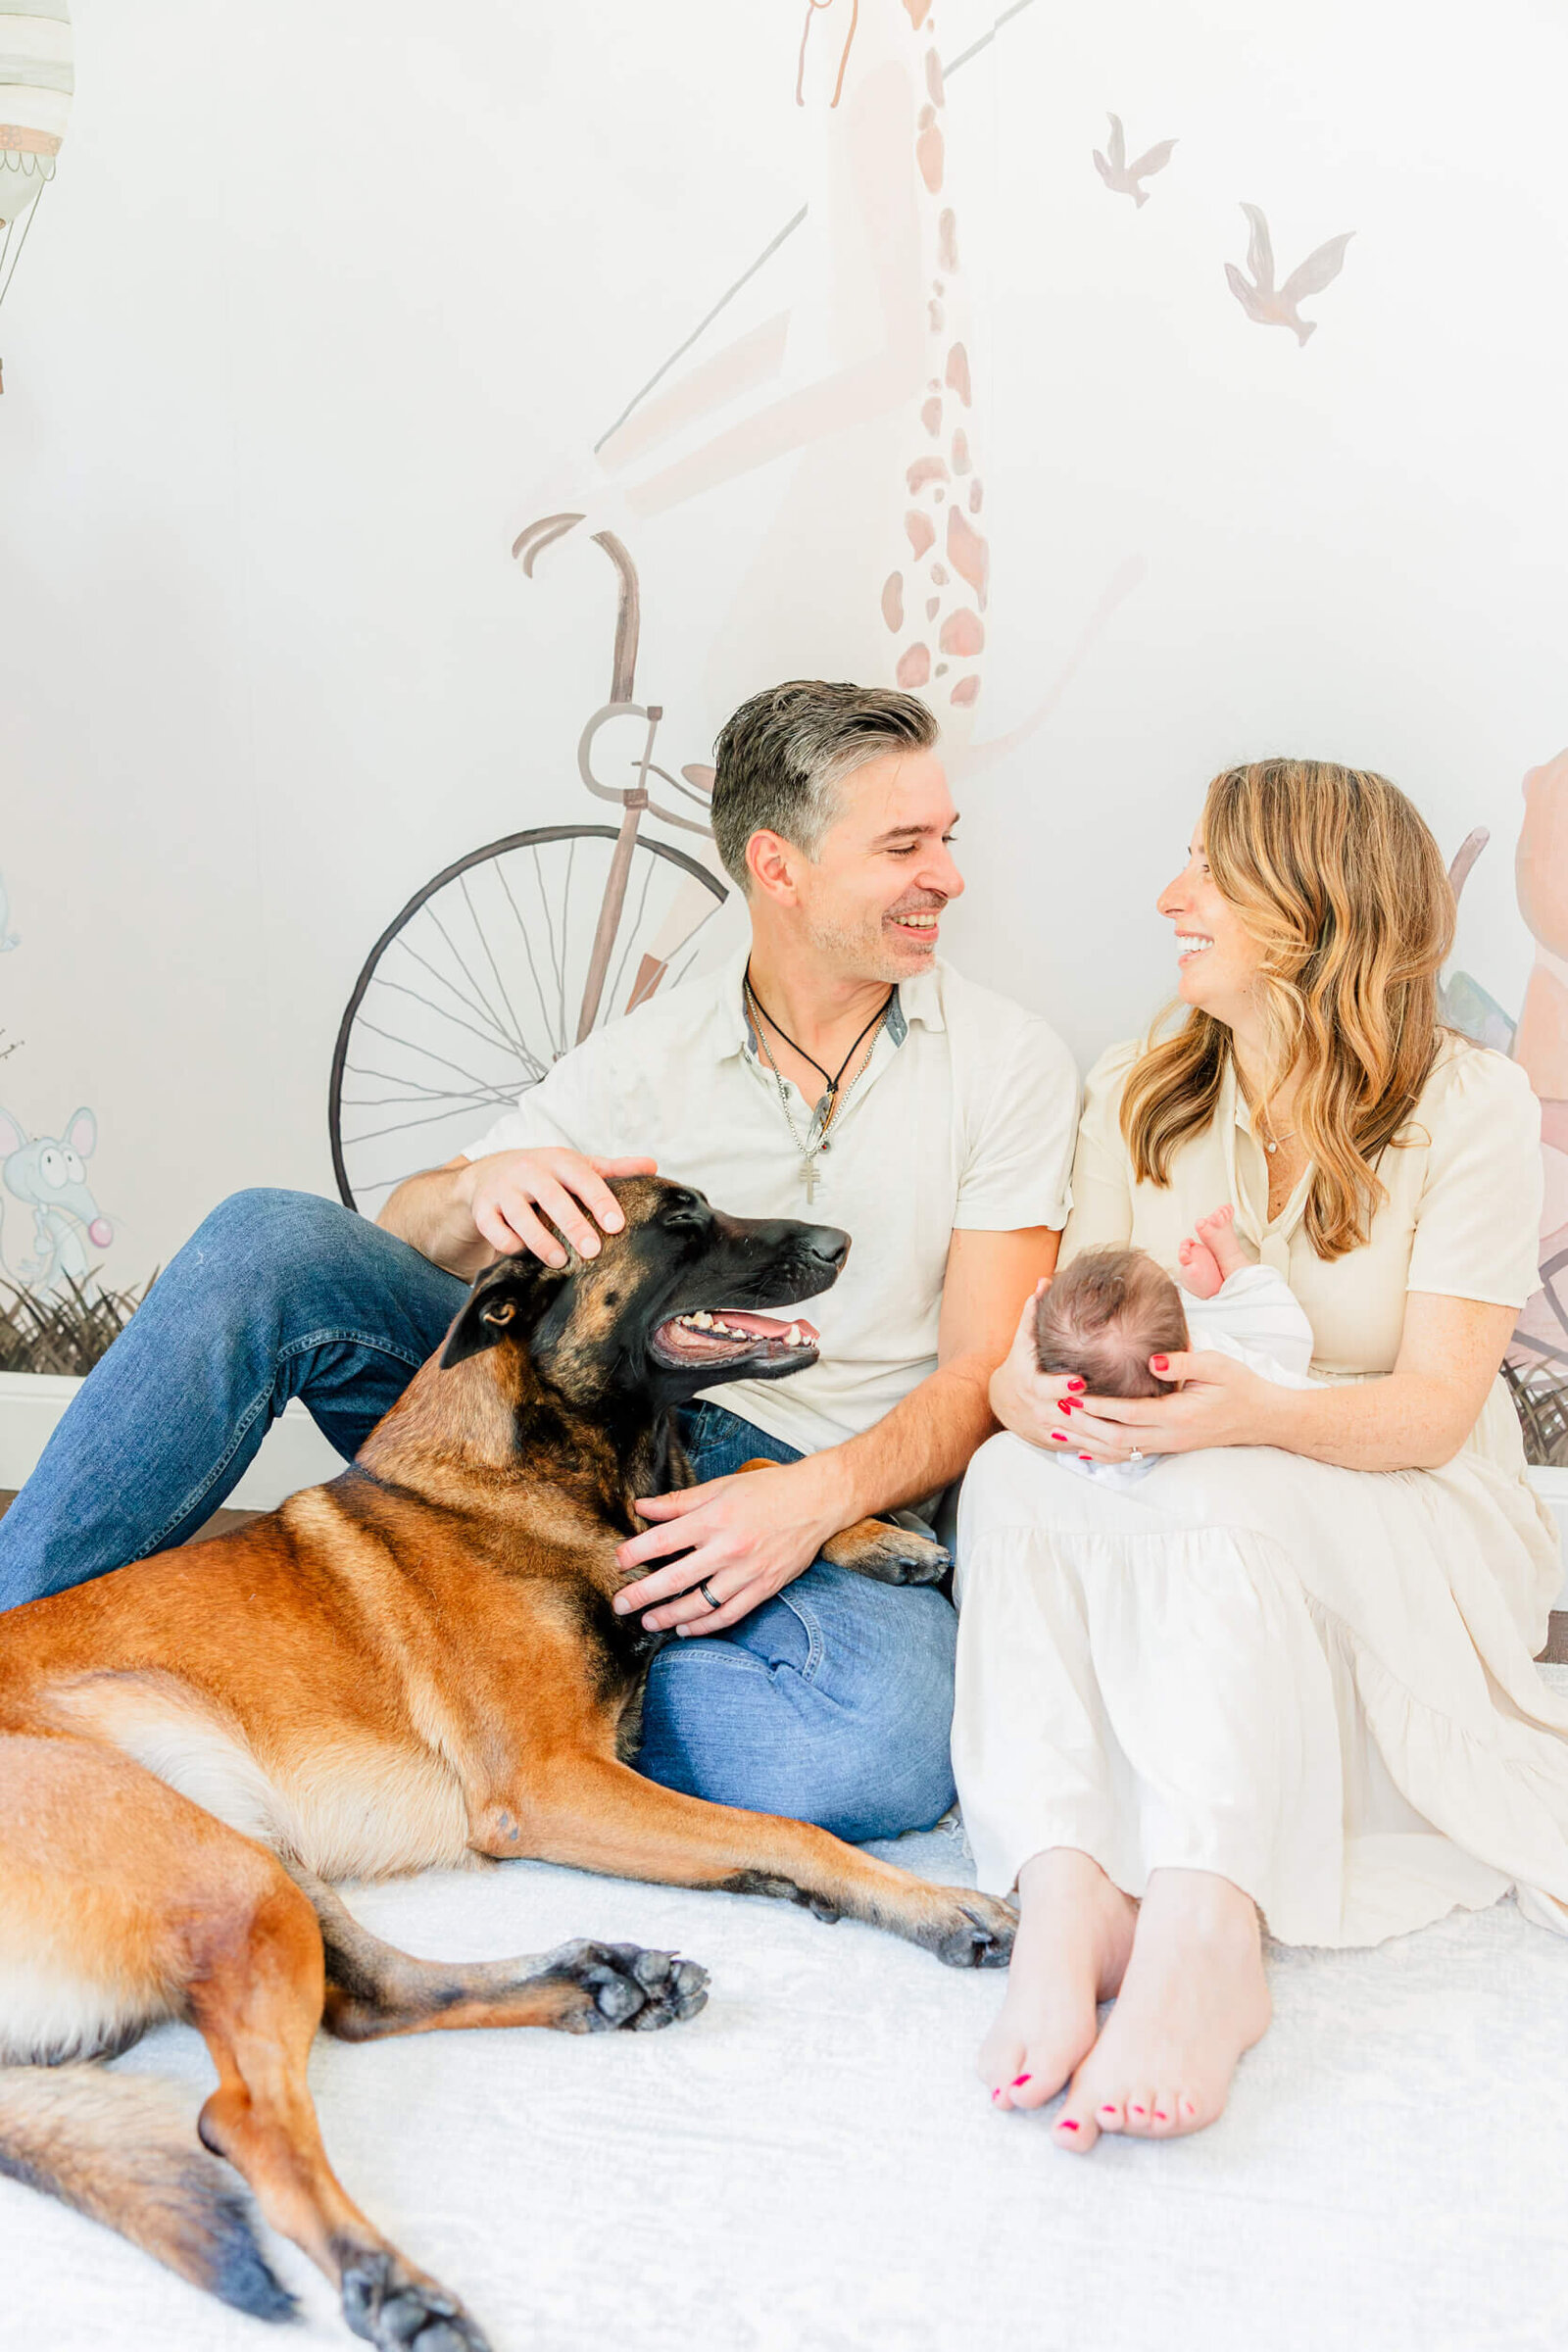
[0, 1178, 1013, 2352]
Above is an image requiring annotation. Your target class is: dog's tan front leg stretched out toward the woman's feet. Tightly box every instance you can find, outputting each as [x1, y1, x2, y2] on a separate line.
[496, 1750, 1015, 1969]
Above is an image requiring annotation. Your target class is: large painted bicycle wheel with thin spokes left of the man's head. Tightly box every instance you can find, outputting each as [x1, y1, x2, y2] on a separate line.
[329, 825, 729, 1216]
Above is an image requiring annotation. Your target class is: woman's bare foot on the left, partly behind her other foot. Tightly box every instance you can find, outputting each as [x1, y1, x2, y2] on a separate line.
[980, 1846, 1138, 2107]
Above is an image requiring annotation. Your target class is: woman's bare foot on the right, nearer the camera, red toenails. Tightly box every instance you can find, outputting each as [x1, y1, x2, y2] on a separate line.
[1054, 1870, 1272, 2150]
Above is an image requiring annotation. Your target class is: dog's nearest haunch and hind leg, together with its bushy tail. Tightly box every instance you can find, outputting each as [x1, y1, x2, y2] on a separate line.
[0, 1739, 484, 2352]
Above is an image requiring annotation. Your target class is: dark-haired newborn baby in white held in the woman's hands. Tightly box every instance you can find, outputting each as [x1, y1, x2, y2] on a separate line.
[1034, 1206, 1316, 1480]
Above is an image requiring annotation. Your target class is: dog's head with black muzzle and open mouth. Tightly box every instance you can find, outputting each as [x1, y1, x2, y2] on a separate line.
[440, 1176, 849, 1411]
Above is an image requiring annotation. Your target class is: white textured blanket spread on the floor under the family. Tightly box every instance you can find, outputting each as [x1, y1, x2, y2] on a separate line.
[0, 1712, 1568, 2352]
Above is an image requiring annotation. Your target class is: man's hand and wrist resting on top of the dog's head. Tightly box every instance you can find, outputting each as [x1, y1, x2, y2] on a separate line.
[376, 1143, 656, 1282]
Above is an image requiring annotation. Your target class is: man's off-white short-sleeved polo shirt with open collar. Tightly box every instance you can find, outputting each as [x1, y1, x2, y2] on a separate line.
[466, 955, 1079, 1453]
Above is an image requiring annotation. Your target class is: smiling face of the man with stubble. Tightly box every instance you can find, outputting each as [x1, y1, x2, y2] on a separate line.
[795, 751, 964, 981]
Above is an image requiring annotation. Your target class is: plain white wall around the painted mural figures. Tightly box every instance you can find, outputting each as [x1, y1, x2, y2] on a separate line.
[0, 0, 1568, 1282]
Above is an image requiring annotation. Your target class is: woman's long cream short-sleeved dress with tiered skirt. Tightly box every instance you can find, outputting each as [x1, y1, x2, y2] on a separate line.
[955, 1040, 1568, 1945]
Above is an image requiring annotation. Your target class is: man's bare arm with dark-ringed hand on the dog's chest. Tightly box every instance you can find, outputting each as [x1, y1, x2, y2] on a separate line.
[613, 1225, 1060, 1635]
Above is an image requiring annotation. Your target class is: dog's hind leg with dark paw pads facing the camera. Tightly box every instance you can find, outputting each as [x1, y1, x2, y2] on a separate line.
[289, 1863, 708, 2041]
